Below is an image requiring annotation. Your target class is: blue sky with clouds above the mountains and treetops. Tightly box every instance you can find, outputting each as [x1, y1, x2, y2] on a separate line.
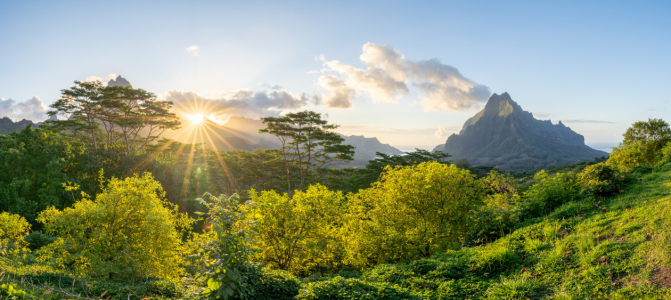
[0, 0, 671, 151]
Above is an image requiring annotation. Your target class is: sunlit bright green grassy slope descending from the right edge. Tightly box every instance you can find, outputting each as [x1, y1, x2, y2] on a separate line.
[303, 168, 671, 299]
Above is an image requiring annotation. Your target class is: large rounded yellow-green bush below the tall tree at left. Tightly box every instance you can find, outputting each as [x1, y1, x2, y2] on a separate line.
[38, 173, 190, 280]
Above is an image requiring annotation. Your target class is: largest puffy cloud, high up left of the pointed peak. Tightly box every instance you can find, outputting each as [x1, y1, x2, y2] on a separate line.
[318, 43, 491, 111]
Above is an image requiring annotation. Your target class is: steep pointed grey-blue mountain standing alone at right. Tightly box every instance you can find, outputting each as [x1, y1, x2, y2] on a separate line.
[434, 93, 608, 170]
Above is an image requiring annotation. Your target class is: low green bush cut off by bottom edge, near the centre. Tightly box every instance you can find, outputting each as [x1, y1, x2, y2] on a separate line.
[296, 277, 421, 300]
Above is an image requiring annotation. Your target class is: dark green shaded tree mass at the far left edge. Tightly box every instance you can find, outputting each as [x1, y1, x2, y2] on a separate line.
[0, 126, 86, 227]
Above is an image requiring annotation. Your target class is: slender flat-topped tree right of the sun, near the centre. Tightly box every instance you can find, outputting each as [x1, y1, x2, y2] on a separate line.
[259, 110, 354, 195]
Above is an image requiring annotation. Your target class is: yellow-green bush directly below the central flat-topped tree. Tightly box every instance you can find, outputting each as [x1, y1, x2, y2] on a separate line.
[246, 184, 345, 274]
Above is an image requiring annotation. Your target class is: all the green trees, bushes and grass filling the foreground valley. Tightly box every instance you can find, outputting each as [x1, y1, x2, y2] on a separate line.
[0, 79, 671, 299]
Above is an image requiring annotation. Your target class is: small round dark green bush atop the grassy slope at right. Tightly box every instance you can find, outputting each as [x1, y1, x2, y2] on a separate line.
[577, 163, 628, 197]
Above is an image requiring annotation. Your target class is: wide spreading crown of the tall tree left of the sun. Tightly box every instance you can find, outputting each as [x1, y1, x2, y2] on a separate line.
[48, 81, 180, 155]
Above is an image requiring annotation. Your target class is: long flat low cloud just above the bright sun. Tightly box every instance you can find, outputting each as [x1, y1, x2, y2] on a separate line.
[164, 89, 308, 123]
